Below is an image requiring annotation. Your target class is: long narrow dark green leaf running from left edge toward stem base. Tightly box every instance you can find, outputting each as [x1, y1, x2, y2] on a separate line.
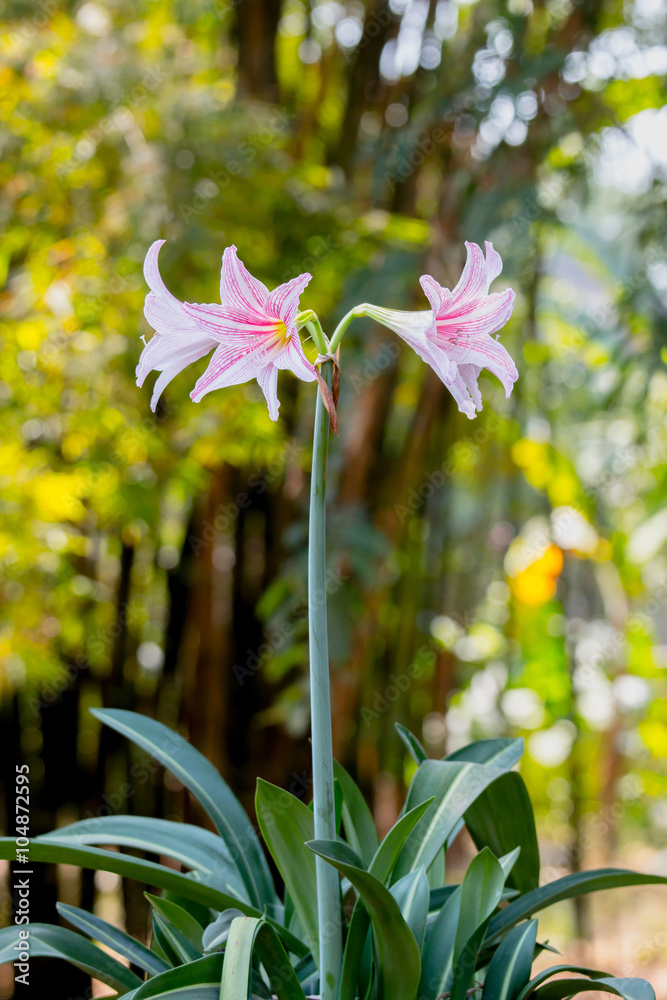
[0, 837, 308, 956]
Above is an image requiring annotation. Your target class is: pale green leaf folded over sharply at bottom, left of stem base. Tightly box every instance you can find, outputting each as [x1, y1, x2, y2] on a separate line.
[220, 917, 305, 1000]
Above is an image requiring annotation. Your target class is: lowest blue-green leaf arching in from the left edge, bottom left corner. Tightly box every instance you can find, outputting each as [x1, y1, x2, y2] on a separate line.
[0, 920, 141, 996]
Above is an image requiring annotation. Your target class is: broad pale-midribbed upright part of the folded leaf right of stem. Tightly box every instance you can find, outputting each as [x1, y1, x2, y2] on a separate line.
[394, 760, 502, 879]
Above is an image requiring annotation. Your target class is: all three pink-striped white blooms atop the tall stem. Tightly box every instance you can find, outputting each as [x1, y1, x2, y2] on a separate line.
[137, 240, 518, 420]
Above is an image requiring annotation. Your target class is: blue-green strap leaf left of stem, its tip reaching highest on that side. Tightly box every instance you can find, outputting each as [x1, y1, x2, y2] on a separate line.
[93, 708, 277, 909]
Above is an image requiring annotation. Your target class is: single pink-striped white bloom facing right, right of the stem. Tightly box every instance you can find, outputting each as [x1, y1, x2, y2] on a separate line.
[366, 243, 519, 419]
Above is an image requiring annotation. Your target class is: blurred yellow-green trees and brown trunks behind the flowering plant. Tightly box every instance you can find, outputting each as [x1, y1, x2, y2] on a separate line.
[0, 0, 667, 985]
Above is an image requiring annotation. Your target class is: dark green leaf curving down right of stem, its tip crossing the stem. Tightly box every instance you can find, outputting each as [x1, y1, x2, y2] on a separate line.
[308, 840, 419, 1000]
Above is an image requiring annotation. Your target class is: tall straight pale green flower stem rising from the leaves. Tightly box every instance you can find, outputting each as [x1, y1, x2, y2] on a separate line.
[308, 361, 342, 1000]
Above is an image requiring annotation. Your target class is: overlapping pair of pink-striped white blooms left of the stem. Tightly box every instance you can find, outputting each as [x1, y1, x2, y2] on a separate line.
[137, 240, 317, 420]
